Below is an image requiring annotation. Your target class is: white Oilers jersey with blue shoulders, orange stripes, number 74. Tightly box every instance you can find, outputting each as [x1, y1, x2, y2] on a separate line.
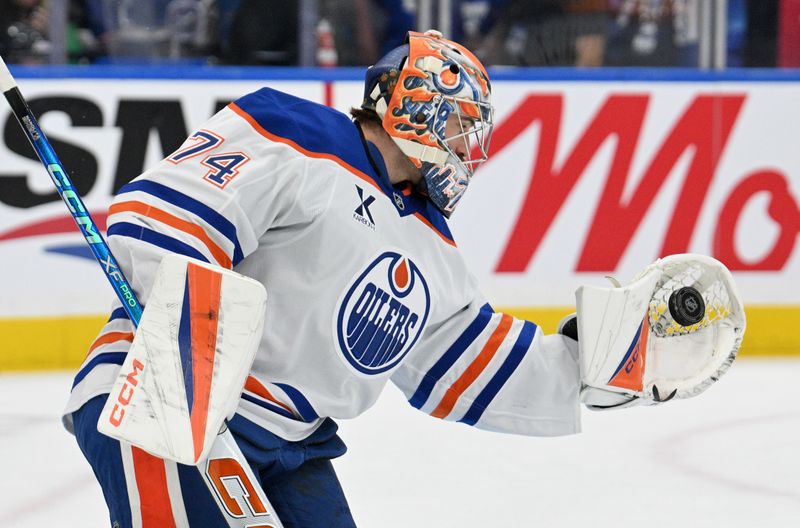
[65, 88, 580, 440]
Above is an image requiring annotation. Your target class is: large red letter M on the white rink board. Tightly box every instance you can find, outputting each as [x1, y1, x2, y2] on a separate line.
[491, 94, 745, 272]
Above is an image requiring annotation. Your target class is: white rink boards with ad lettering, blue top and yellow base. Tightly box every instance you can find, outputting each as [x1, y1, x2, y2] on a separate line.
[0, 67, 800, 370]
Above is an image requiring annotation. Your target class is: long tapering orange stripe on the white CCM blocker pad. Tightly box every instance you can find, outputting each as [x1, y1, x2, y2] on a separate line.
[186, 264, 222, 460]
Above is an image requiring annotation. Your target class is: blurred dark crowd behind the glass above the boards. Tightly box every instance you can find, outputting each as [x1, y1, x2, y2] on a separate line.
[0, 0, 785, 67]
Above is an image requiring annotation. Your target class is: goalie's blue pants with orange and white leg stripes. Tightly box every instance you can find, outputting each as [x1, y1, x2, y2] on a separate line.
[73, 395, 355, 528]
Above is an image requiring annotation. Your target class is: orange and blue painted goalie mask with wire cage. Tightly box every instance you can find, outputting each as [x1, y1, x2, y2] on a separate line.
[361, 31, 492, 217]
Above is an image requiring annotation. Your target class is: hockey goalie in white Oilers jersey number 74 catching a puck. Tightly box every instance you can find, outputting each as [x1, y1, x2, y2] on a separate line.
[53, 32, 745, 528]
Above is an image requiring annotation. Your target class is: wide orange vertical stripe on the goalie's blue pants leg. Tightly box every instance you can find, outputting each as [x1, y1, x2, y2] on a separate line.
[131, 446, 175, 528]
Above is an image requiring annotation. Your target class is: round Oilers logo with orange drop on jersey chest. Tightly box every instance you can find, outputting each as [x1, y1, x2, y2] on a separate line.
[334, 251, 431, 374]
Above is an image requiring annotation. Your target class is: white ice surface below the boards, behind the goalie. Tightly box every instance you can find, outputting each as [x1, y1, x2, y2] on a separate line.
[0, 359, 800, 528]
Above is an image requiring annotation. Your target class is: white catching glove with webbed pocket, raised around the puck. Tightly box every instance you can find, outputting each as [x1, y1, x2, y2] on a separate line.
[576, 254, 745, 409]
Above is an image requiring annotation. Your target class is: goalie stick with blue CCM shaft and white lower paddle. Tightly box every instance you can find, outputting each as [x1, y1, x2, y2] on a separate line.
[0, 57, 282, 528]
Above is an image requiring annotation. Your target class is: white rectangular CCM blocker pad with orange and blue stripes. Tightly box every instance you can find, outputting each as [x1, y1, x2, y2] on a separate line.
[97, 255, 267, 465]
